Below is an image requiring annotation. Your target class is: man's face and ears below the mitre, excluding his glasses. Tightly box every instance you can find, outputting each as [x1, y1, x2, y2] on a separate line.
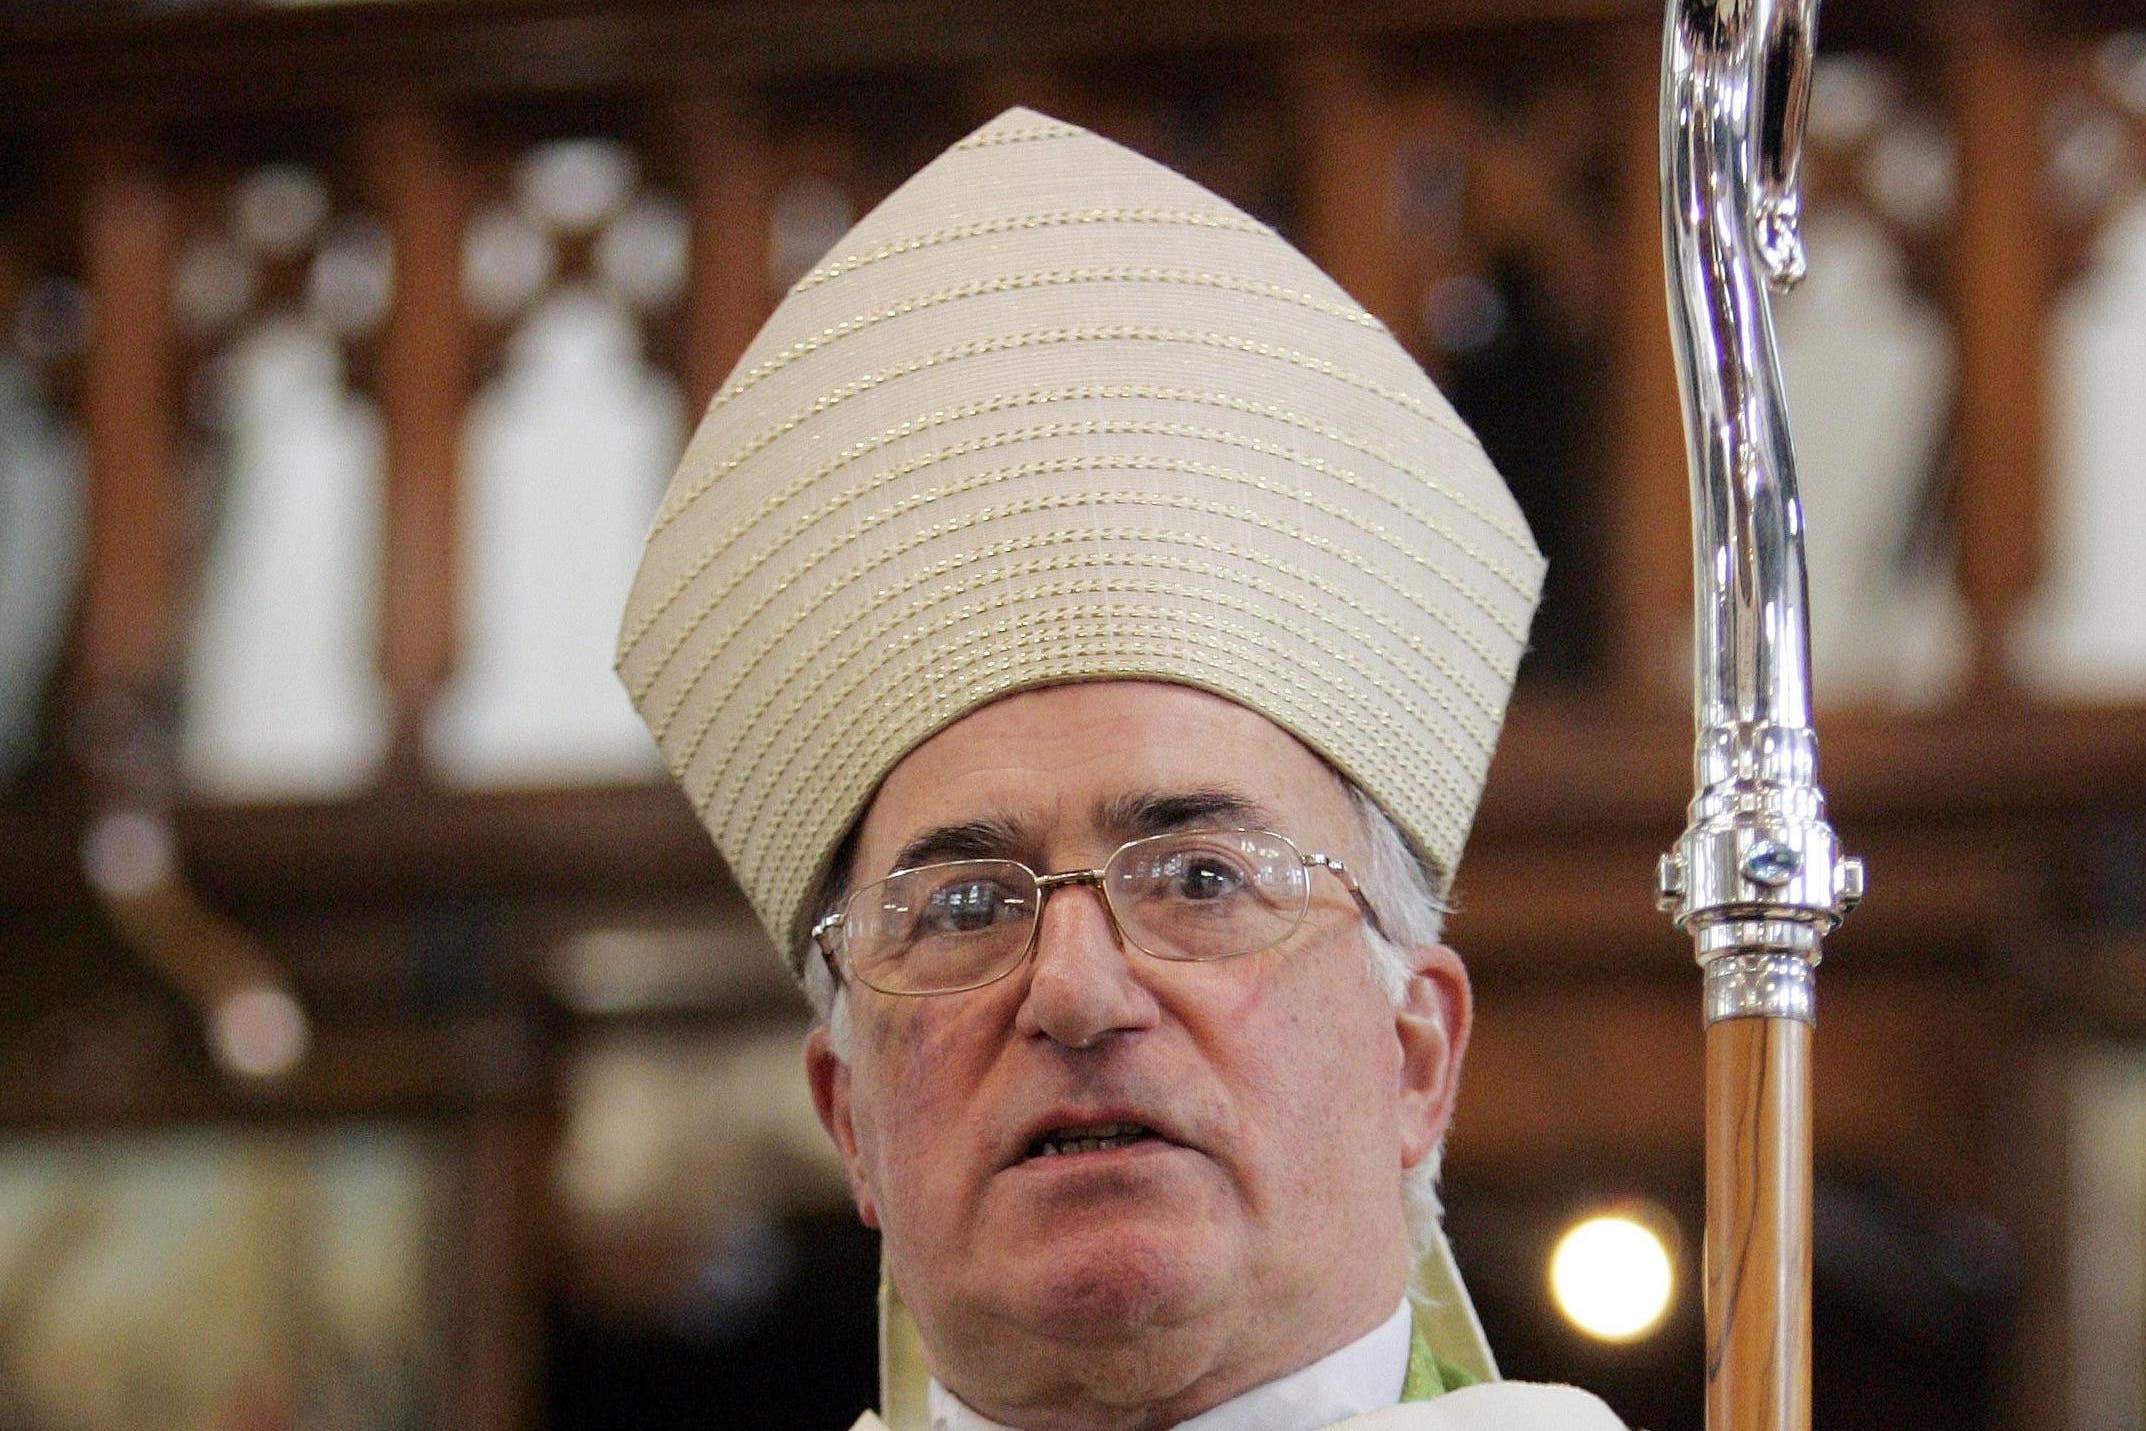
[807, 682, 1468, 1416]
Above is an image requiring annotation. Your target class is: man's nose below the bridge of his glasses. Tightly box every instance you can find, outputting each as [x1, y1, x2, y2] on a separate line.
[1015, 884, 1161, 1049]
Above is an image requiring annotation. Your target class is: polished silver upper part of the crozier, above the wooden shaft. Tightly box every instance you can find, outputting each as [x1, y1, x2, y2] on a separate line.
[1661, 0, 1863, 1021]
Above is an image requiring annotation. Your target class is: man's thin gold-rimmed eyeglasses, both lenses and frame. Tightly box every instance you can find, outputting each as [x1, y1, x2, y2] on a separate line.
[811, 830, 1386, 995]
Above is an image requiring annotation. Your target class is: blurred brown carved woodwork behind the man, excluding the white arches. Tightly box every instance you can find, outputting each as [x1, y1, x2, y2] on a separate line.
[0, 0, 2146, 1431]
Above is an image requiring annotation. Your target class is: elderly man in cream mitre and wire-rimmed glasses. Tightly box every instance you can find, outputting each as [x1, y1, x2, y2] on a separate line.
[620, 109, 1618, 1431]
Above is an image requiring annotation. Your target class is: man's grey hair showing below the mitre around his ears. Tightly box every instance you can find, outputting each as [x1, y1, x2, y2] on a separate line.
[803, 779, 1449, 1262]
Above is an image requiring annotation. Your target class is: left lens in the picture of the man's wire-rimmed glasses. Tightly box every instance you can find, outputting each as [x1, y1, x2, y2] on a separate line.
[841, 860, 1037, 993]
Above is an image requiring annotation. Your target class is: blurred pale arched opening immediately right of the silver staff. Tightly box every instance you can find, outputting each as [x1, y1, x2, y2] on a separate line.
[1775, 210, 1970, 706]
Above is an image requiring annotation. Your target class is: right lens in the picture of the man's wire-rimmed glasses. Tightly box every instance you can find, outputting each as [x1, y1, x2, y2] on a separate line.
[1103, 830, 1311, 959]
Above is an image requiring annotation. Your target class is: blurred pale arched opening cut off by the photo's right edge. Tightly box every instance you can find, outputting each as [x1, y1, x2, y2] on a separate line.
[2015, 200, 2146, 697]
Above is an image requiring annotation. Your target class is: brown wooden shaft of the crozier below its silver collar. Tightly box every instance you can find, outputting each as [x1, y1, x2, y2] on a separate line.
[1706, 1019, 1811, 1431]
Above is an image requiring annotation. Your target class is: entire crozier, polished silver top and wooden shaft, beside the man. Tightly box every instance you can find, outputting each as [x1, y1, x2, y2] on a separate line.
[1661, 0, 1863, 1431]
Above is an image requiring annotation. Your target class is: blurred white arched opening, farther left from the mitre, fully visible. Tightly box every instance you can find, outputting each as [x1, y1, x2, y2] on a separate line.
[180, 315, 393, 798]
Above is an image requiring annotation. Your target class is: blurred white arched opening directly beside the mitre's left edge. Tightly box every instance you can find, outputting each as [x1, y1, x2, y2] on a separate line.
[429, 285, 685, 785]
